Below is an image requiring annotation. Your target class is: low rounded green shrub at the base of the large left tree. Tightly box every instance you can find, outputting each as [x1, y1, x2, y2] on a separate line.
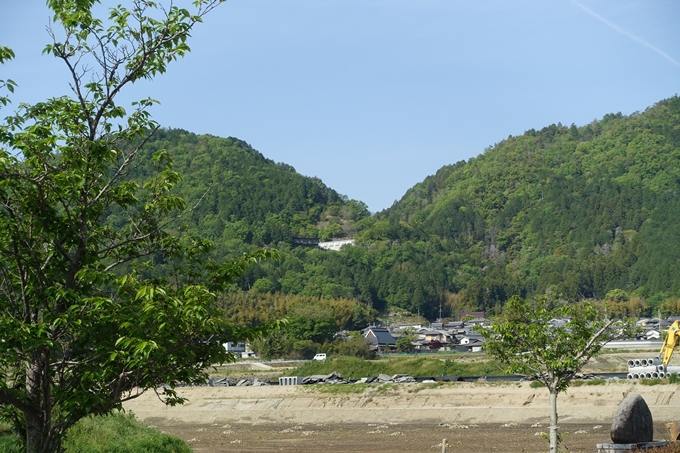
[63, 413, 191, 453]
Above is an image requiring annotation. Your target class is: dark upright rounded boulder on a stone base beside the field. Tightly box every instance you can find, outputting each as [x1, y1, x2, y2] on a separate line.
[611, 393, 654, 444]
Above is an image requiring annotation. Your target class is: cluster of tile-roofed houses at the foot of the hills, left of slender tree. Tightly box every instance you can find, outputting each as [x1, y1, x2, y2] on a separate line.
[362, 312, 486, 353]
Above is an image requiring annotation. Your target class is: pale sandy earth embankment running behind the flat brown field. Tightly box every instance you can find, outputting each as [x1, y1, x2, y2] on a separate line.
[125, 381, 680, 424]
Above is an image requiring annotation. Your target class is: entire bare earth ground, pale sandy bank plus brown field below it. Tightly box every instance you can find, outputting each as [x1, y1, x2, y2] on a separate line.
[126, 381, 680, 453]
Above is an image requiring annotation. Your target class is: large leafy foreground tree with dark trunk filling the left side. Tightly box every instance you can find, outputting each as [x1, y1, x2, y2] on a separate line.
[0, 0, 273, 453]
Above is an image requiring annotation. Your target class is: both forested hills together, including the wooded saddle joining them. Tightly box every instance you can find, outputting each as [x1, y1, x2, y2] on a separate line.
[130, 96, 680, 317]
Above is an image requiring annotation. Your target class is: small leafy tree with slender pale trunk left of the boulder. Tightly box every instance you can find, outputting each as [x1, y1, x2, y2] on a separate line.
[482, 296, 614, 453]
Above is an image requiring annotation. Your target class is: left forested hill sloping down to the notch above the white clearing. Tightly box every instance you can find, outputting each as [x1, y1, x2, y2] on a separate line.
[126, 129, 369, 256]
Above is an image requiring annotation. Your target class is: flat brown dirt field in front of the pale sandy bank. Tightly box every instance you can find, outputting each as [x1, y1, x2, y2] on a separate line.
[147, 419, 664, 453]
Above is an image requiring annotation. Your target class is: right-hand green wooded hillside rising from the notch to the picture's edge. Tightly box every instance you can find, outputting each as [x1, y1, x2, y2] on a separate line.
[379, 97, 680, 309]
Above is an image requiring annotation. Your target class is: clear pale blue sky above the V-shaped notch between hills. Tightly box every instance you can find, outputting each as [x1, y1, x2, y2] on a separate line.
[0, 0, 680, 212]
